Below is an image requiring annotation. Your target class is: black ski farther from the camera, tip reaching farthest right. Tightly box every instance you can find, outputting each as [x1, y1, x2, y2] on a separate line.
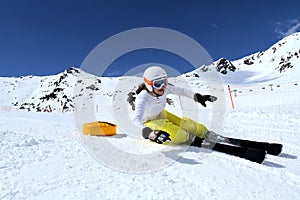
[225, 137, 282, 156]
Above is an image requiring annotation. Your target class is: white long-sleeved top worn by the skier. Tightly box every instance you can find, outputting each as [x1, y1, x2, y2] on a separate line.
[133, 85, 194, 128]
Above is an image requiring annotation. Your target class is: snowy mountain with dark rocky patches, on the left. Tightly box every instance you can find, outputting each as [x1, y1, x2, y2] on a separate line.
[0, 68, 101, 112]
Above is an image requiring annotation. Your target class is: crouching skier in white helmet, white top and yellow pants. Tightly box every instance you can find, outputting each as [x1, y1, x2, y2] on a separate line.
[134, 66, 218, 146]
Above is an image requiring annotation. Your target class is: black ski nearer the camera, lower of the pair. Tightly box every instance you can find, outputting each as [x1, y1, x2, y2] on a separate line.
[202, 143, 266, 164]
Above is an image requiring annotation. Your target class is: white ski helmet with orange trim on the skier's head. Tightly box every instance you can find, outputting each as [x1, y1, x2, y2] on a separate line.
[143, 66, 168, 92]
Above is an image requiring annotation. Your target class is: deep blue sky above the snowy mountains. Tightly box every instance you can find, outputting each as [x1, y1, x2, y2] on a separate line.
[0, 0, 300, 77]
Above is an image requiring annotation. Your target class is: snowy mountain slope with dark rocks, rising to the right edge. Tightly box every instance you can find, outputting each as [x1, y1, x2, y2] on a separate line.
[189, 33, 300, 84]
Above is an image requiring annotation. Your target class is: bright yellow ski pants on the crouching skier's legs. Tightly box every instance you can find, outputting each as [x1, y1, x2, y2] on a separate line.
[144, 110, 208, 144]
